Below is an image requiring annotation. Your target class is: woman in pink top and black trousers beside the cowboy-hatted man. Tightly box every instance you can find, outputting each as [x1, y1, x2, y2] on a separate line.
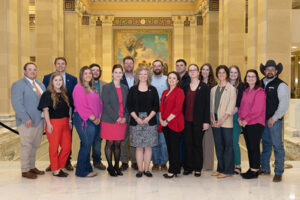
[238, 69, 266, 179]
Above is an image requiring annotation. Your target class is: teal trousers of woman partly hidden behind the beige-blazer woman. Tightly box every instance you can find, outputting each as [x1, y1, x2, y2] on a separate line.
[232, 113, 242, 165]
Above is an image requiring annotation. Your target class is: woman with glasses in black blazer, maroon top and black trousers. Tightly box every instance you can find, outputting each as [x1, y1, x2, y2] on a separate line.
[183, 64, 210, 177]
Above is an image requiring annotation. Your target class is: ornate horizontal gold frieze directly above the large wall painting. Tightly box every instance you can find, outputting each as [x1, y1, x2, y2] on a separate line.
[113, 17, 173, 26]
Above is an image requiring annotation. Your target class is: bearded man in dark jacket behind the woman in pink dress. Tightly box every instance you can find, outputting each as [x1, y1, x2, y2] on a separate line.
[120, 56, 138, 171]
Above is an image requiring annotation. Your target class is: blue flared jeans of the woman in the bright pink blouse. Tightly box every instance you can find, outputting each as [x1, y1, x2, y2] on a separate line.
[74, 112, 97, 177]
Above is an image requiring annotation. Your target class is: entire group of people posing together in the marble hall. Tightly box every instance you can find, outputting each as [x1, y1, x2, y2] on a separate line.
[11, 56, 289, 182]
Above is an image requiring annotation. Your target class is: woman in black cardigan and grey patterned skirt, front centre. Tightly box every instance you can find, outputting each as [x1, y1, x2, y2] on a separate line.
[127, 67, 159, 178]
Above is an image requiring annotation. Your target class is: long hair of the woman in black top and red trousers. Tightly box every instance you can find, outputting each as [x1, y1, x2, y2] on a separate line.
[47, 72, 70, 110]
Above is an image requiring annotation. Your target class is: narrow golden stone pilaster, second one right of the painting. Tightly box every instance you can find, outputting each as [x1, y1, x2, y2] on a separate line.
[187, 16, 198, 64]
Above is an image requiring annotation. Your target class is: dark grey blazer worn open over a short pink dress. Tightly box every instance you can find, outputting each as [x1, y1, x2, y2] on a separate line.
[101, 82, 129, 124]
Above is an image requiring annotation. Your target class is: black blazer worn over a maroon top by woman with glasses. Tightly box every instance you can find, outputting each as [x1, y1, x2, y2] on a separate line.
[183, 81, 210, 126]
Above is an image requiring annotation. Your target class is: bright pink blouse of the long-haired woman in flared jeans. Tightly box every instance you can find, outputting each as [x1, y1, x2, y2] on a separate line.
[72, 83, 102, 122]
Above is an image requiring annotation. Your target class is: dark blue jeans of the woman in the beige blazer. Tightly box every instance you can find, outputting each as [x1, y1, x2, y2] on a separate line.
[212, 127, 234, 174]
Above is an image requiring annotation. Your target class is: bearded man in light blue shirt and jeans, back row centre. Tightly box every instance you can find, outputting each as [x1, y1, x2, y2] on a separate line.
[151, 60, 168, 171]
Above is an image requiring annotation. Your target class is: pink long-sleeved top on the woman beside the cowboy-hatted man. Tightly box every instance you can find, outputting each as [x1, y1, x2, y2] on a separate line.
[238, 88, 266, 126]
